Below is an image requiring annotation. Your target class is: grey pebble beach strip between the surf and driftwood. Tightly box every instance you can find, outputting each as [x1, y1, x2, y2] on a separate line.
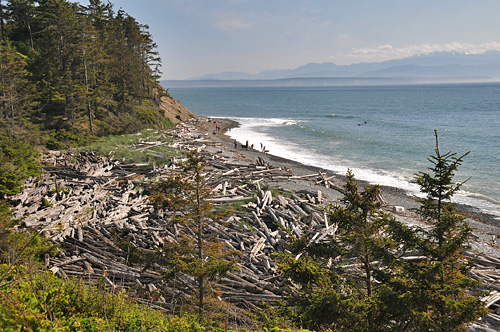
[192, 116, 500, 257]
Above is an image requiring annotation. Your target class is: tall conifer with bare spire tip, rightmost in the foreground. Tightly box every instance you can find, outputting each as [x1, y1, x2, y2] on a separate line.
[393, 131, 485, 331]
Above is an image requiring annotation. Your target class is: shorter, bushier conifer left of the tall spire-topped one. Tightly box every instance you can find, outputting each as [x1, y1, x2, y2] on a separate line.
[278, 171, 400, 331]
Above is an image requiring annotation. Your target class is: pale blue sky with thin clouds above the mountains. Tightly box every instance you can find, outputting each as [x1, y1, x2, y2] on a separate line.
[80, 0, 500, 80]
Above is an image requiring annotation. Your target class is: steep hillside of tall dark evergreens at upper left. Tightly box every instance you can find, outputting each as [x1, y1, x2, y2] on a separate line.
[0, 0, 188, 149]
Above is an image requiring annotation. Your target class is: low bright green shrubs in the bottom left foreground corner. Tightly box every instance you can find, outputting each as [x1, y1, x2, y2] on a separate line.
[0, 265, 207, 332]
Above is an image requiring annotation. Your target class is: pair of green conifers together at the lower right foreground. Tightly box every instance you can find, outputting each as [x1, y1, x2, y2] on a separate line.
[277, 133, 486, 331]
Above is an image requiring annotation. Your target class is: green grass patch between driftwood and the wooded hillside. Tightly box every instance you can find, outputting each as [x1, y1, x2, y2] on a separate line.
[82, 129, 183, 166]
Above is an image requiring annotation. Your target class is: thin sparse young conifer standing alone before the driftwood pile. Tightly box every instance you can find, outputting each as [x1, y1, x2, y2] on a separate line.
[150, 151, 236, 315]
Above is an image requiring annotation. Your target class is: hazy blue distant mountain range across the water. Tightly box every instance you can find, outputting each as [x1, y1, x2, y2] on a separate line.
[162, 50, 500, 87]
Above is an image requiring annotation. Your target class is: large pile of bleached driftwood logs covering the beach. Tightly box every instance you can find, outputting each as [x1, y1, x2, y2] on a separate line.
[12, 126, 500, 324]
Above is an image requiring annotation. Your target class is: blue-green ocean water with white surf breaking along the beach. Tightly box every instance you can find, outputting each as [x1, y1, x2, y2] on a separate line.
[169, 83, 500, 216]
